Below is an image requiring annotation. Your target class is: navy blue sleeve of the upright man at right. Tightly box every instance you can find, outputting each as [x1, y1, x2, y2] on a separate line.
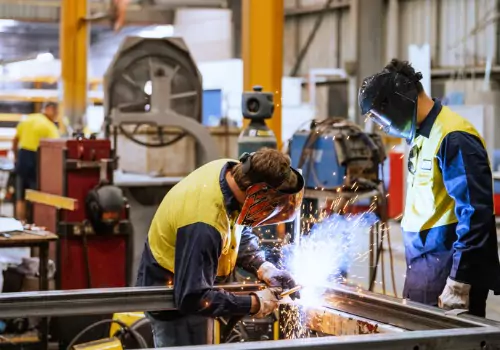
[437, 131, 494, 283]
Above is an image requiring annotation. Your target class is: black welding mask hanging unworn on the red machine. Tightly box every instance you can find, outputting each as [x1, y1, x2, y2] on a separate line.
[85, 183, 125, 234]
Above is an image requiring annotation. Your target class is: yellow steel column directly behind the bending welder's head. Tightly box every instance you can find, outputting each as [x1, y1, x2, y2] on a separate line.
[242, 0, 285, 147]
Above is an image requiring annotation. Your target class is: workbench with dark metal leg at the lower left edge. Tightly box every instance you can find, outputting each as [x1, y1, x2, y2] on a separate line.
[0, 231, 58, 349]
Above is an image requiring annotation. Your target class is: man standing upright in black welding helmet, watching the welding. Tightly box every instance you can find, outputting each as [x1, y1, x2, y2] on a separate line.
[359, 59, 500, 317]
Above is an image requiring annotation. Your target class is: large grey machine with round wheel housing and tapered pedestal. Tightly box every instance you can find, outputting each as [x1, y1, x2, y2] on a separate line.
[103, 37, 219, 280]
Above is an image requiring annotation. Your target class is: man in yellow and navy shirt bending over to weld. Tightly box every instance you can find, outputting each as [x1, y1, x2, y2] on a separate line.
[137, 149, 304, 347]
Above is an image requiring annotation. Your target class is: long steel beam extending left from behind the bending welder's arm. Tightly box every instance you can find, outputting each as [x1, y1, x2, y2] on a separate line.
[0, 284, 262, 318]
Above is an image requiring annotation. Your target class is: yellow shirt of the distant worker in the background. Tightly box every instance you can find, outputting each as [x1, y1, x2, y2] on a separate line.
[16, 113, 59, 152]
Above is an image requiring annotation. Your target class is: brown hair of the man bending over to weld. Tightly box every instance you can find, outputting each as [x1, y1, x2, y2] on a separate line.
[231, 148, 298, 191]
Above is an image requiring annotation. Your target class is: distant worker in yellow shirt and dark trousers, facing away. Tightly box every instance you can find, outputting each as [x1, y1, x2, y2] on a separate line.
[12, 102, 59, 220]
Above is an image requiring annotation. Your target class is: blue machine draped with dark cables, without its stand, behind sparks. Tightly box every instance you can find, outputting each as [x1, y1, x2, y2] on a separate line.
[290, 118, 386, 190]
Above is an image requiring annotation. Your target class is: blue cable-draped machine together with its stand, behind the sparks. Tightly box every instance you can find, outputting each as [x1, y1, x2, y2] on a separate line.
[288, 118, 396, 295]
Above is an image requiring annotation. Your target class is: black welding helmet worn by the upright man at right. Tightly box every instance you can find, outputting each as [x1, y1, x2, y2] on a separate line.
[358, 69, 422, 144]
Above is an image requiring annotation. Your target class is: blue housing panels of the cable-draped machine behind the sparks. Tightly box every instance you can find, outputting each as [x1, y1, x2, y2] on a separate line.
[290, 131, 346, 189]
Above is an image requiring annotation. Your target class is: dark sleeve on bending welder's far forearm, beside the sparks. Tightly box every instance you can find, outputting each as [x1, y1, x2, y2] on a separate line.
[236, 227, 266, 274]
